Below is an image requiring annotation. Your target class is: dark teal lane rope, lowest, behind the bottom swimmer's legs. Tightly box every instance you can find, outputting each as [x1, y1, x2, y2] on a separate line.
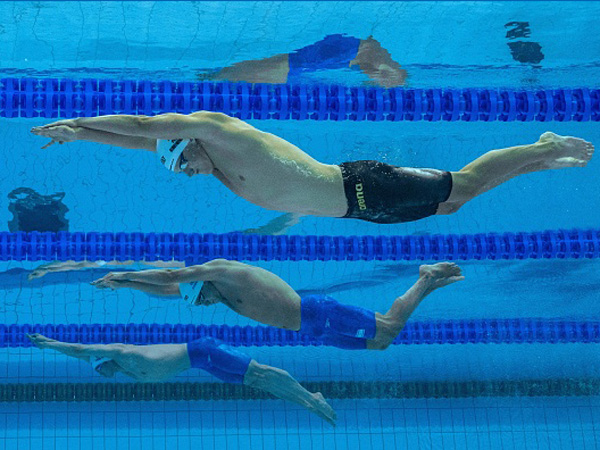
[0, 378, 600, 403]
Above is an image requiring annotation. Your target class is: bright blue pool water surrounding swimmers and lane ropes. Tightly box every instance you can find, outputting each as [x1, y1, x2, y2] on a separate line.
[0, 2, 600, 450]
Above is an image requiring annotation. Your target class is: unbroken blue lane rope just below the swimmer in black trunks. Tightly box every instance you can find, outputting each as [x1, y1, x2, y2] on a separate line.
[0, 229, 600, 263]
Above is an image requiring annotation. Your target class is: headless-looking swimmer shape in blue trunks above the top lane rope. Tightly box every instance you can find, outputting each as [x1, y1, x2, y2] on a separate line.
[199, 34, 407, 88]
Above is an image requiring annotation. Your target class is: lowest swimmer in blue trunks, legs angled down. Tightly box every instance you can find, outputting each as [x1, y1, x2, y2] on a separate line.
[27, 334, 337, 425]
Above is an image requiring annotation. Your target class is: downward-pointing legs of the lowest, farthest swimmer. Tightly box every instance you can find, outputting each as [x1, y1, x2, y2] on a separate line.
[244, 360, 337, 426]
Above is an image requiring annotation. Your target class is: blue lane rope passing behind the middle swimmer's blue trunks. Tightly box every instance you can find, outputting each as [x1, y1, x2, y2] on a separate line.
[8, 319, 600, 347]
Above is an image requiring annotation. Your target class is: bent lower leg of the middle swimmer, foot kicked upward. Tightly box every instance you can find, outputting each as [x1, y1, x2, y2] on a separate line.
[367, 262, 464, 350]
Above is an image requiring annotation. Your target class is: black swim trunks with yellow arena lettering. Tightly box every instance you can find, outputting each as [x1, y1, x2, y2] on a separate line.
[340, 161, 452, 223]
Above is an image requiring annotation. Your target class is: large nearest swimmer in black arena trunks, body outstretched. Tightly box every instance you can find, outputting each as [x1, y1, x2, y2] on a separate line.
[31, 111, 594, 223]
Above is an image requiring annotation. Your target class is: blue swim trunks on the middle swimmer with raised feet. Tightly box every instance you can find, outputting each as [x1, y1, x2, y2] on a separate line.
[300, 295, 376, 350]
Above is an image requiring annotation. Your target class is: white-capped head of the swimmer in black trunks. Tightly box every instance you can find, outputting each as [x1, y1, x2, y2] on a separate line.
[156, 139, 215, 177]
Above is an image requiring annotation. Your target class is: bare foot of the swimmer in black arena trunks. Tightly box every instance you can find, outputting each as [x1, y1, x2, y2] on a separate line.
[538, 131, 594, 169]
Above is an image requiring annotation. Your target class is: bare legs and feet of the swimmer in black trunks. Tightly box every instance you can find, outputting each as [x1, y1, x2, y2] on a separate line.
[437, 132, 594, 214]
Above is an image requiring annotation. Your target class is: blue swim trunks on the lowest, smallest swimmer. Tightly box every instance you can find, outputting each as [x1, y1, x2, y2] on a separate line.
[187, 337, 252, 384]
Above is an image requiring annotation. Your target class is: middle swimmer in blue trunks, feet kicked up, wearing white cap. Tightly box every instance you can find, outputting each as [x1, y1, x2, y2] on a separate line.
[92, 259, 464, 350]
